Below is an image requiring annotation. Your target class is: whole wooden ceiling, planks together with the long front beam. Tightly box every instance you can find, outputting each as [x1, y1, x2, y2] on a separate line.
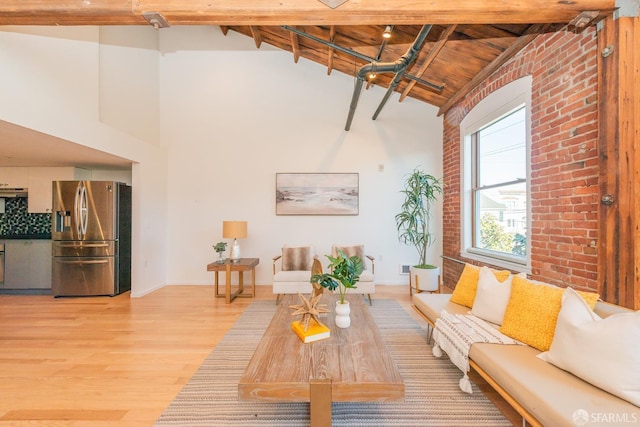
[0, 0, 615, 120]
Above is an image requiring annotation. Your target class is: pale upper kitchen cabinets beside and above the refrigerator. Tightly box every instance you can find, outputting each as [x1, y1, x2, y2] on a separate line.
[27, 167, 91, 213]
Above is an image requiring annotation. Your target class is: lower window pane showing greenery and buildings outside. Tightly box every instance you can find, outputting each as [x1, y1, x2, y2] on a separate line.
[474, 183, 527, 256]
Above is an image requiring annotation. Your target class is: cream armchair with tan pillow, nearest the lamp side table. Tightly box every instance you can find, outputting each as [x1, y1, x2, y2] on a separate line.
[273, 245, 319, 304]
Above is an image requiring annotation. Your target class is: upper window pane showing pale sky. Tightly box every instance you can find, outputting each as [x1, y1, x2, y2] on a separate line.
[477, 108, 527, 187]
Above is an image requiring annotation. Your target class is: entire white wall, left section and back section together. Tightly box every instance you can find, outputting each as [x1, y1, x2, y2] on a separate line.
[0, 27, 442, 296]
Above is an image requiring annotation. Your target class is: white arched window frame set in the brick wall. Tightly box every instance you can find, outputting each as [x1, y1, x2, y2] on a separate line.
[459, 76, 533, 273]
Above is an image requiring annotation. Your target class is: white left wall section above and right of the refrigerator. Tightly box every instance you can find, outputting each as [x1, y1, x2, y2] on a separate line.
[0, 26, 167, 295]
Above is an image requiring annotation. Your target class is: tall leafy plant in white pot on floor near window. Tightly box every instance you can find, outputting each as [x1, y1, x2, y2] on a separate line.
[395, 168, 443, 291]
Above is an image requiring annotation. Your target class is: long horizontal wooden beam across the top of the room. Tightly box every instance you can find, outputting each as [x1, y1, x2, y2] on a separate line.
[0, 0, 616, 25]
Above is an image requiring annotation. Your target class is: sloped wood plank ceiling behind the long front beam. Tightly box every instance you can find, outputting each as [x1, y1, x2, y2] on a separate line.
[222, 23, 565, 121]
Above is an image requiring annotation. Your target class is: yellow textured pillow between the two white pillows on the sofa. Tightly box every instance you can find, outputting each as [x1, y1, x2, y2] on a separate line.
[500, 276, 598, 351]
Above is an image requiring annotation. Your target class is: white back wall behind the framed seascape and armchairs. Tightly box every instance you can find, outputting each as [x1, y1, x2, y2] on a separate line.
[160, 27, 442, 284]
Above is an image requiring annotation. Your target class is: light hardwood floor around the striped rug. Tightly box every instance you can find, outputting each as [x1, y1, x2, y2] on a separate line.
[0, 285, 521, 426]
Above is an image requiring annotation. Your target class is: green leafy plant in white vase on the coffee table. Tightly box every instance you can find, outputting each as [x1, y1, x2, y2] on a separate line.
[310, 250, 364, 328]
